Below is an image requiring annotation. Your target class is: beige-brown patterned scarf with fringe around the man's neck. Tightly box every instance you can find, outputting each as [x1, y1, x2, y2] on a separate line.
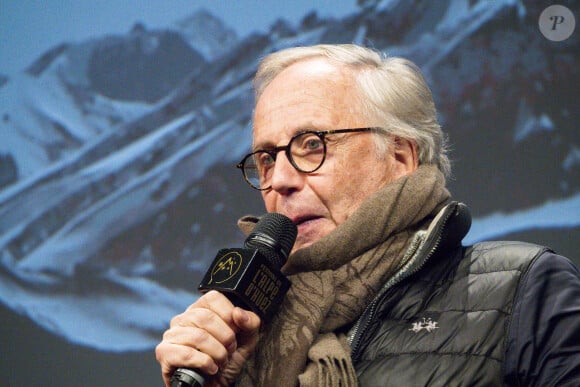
[239, 166, 450, 387]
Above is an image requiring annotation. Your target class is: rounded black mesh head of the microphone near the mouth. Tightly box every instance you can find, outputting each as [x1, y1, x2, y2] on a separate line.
[244, 212, 298, 270]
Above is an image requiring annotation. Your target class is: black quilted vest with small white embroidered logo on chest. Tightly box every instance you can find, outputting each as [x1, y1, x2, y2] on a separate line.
[351, 203, 543, 387]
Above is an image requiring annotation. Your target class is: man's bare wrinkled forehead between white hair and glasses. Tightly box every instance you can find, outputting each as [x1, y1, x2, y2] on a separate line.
[253, 58, 365, 149]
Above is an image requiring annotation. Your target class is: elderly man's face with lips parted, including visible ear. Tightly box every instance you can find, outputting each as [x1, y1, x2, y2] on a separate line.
[253, 58, 416, 250]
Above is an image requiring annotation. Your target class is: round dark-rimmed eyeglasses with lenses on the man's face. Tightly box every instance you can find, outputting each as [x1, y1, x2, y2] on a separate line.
[236, 127, 379, 191]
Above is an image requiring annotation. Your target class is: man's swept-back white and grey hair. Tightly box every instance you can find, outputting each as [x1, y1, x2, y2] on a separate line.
[254, 44, 451, 176]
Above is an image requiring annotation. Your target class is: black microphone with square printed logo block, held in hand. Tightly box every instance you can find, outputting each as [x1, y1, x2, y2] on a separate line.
[171, 213, 298, 387]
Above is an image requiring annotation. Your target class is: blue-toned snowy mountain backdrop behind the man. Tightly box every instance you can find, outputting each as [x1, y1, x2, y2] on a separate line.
[0, 0, 580, 358]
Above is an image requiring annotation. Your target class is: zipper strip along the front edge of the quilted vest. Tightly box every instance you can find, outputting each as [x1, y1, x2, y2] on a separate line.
[347, 202, 458, 363]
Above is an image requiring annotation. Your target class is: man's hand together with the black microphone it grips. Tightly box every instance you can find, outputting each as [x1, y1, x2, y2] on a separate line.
[156, 213, 297, 387]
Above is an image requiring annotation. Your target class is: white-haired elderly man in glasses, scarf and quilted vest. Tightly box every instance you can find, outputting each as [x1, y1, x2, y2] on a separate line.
[156, 45, 580, 386]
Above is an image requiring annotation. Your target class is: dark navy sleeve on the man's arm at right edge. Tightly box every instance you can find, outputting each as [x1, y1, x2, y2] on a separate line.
[504, 249, 580, 386]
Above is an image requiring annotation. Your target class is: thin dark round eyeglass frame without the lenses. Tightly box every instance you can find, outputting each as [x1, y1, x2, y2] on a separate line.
[236, 126, 382, 191]
